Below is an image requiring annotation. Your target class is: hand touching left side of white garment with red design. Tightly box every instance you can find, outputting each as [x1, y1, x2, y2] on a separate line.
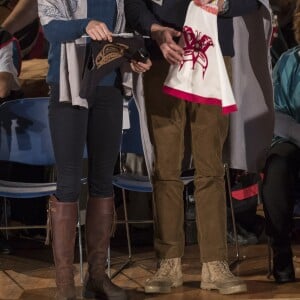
[151, 24, 184, 64]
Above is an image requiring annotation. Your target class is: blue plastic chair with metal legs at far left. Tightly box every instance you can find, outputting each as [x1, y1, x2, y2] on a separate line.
[0, 97, 87, 278]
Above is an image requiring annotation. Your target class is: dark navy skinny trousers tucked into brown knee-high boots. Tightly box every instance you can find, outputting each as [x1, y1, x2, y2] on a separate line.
[49, 85, 123, 202]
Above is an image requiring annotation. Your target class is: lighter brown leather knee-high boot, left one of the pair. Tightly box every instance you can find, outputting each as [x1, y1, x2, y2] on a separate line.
[49, 196, 78, 300]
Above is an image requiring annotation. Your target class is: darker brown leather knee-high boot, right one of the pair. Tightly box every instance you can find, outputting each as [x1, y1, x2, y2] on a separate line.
[83, 197, 127, 300]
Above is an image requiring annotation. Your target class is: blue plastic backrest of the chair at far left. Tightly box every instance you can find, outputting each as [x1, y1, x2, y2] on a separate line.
[0, 97, 55, 166]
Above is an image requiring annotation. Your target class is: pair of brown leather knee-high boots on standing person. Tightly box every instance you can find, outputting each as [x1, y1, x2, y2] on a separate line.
[49, 196, 127, 300]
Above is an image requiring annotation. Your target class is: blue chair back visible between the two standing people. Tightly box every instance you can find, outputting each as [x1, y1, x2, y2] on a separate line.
[121, 99, 144, 155]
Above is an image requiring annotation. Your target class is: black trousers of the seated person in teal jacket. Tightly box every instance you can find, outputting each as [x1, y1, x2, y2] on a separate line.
[262, 142, 300, 245]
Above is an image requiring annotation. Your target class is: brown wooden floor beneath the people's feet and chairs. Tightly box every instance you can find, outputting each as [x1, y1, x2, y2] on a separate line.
[0, 236, 300, 300]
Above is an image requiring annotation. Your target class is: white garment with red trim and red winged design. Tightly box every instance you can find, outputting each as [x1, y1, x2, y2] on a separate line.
[163, 1, 237, 113]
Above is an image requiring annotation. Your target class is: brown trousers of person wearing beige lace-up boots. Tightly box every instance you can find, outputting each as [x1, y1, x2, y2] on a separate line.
[144, 60, 228, 262]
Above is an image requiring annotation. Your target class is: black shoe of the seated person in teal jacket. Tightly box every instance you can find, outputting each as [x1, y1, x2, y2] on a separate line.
[273, 247, 296, 283]
